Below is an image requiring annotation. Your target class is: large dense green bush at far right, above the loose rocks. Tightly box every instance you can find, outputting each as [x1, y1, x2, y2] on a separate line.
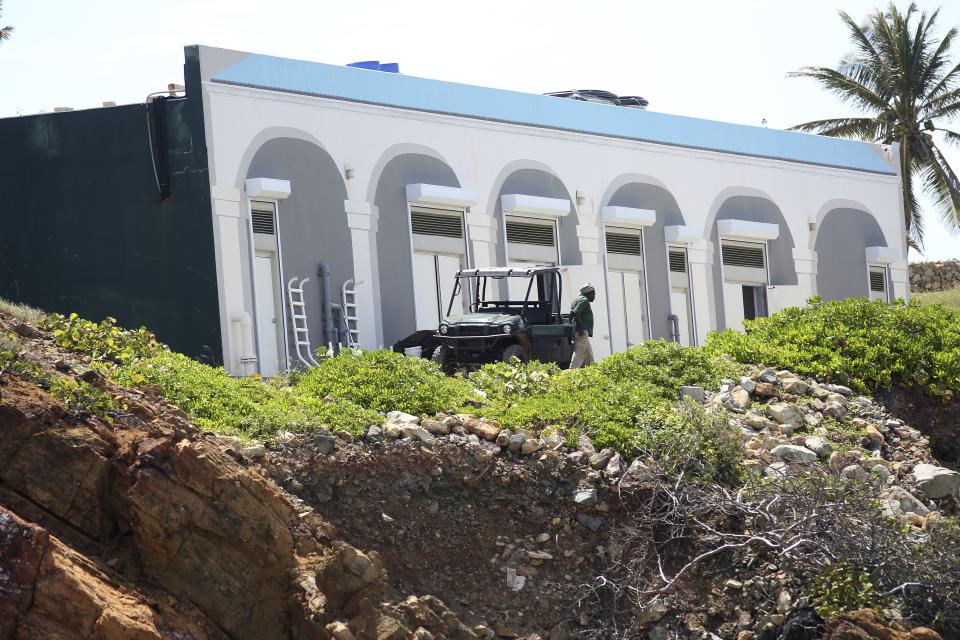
[707, 298, 960, 397]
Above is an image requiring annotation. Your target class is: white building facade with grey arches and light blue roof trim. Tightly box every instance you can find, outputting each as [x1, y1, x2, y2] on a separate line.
[193, 47, 909, 374]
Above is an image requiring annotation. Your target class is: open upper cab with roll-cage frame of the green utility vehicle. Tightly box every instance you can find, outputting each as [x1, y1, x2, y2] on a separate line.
[447, 271, 561, 321]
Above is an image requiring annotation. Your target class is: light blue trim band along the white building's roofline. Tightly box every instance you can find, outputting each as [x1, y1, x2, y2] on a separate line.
[211, 54, 896, 175]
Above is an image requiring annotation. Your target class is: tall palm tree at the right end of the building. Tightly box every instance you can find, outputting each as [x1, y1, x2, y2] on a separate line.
[789, 2, 960, 247]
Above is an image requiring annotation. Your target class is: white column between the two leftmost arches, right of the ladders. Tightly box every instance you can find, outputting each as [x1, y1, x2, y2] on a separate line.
[344, 200, 383, 349]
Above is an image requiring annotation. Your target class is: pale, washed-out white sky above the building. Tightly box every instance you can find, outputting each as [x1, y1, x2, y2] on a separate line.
[0, 0, 960, 261]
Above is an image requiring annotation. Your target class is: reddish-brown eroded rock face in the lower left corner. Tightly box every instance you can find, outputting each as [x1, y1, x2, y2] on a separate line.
[0, 375, 474, 640]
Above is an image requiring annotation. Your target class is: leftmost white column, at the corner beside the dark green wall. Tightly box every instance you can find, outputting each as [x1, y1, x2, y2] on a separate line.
[210, 186, 256, 376]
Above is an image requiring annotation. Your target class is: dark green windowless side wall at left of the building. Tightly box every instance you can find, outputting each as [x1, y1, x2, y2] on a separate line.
[0, 47, 223, 362]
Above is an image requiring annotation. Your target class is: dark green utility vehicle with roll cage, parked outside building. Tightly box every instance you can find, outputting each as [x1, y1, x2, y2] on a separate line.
[433, 267, 576, 371]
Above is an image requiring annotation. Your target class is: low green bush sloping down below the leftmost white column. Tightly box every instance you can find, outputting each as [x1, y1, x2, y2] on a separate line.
[112, 352, 383, 440]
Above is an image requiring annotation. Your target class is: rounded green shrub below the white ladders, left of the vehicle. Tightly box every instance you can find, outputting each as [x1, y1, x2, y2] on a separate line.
[293, 350, 478, 415]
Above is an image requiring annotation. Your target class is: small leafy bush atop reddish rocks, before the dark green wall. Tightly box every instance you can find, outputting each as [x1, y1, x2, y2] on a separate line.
[39, 313, 167, 364]
